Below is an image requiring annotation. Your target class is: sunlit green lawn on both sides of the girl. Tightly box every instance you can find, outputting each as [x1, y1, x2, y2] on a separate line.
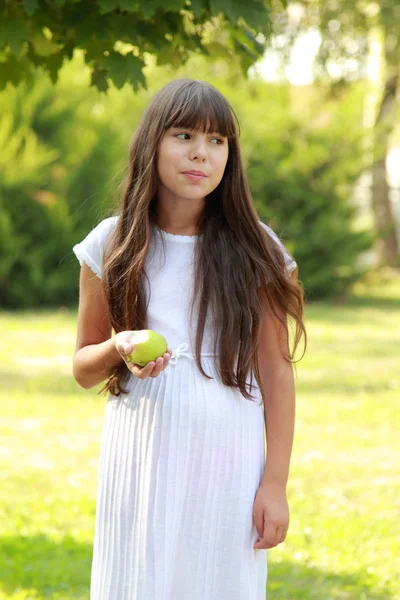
[0, 272, 400, 600]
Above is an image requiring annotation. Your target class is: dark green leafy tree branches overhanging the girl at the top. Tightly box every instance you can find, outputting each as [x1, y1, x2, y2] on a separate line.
[0, 0, 273, 91]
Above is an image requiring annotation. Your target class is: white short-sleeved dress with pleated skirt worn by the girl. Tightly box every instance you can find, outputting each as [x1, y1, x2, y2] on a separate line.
[73, 217, 296, 600]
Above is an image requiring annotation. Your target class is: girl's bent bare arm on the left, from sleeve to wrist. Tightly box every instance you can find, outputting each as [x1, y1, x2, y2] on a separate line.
[73, 263, 123, 389]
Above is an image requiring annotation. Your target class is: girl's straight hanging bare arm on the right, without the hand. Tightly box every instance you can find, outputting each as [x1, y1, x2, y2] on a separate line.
[258, 268, 297, 487]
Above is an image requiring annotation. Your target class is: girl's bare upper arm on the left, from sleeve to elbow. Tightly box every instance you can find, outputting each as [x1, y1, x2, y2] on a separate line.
[75, 263, 112, 353]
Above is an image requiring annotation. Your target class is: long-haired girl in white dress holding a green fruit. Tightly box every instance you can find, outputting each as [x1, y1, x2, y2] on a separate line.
[73, 79, 306, 600]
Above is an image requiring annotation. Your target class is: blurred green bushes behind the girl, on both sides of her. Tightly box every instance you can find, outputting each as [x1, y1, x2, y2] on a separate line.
[0, 51, 372, 307]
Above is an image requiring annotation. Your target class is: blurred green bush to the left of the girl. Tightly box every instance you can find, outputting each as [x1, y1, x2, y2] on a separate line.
[0, 63, 126, 307]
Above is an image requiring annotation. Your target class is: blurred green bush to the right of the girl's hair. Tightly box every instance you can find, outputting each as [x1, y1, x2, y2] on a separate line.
[236, 85, 374, 300]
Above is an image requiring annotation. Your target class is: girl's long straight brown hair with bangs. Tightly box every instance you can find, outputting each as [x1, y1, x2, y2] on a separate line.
[99, 79, 307, 400]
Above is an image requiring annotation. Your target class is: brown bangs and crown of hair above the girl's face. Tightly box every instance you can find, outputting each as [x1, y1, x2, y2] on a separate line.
[164, 82, 239, 138]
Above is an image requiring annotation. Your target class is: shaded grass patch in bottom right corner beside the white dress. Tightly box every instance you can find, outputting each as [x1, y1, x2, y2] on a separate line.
[267, 561, 397, 600]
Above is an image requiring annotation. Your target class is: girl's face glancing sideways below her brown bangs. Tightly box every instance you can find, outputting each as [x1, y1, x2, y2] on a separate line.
[157, 127, 229, 199]
